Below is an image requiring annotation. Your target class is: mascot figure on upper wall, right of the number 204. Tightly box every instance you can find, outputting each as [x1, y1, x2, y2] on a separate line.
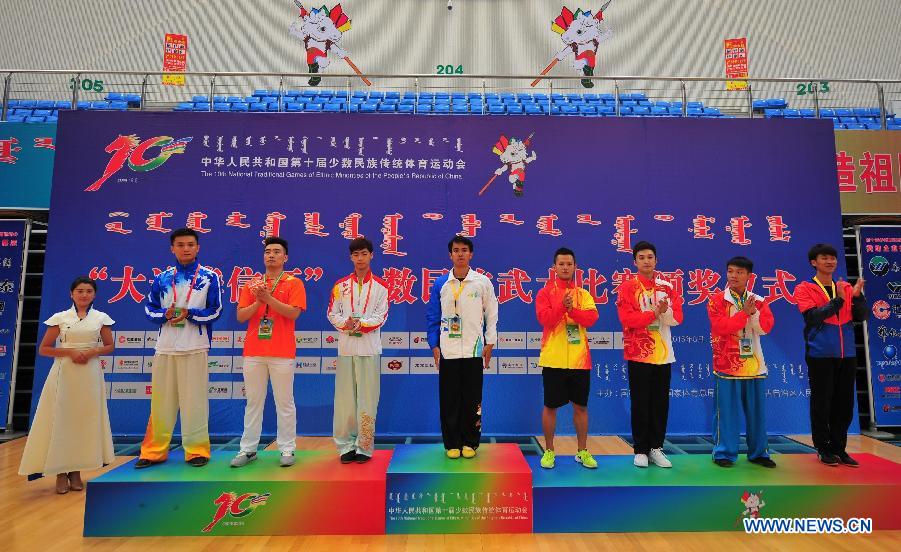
[532, 0, 613, 88]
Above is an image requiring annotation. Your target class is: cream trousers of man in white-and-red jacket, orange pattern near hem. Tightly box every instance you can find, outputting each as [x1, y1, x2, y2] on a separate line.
[332, 355, 381, 456]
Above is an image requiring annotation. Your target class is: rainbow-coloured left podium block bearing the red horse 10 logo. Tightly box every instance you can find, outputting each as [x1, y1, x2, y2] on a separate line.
[84, 450, 391, 537]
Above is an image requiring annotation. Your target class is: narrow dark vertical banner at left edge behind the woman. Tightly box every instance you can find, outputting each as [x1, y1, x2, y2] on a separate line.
[0, 220, 28, 429]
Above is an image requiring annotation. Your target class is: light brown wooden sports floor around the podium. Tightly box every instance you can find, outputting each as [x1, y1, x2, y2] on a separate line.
[0, 435, 901, 552]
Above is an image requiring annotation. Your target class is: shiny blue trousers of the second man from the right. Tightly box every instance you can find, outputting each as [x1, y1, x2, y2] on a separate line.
[713, 376, 769, 462]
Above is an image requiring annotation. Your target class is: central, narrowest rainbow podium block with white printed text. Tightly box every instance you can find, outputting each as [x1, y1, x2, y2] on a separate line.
[385, 443, 532, 533]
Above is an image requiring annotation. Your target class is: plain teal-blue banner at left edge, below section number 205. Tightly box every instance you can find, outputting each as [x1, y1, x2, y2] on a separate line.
[0, 123, 56, 209]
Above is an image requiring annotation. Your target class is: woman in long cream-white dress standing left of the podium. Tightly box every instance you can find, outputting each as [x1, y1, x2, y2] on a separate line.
[19, 277, 115, 494]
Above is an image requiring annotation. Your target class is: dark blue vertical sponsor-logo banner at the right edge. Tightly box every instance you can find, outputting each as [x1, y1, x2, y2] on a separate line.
[857, 226, 901, 427]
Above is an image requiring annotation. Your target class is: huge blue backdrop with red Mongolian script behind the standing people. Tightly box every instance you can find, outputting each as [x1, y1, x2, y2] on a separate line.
[34, 112, 843, 435]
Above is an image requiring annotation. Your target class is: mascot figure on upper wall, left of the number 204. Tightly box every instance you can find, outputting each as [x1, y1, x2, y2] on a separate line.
[289, 0, 372, 86]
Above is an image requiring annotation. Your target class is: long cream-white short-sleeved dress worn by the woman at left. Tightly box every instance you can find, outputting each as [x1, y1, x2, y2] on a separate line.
[19, 307, 115, 476]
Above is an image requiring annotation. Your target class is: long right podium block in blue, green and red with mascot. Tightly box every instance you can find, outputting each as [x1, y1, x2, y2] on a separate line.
[528, 454, 901, 533]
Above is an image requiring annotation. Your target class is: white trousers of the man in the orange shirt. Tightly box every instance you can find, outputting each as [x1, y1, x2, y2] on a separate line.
[241, 357, 297, 453]
